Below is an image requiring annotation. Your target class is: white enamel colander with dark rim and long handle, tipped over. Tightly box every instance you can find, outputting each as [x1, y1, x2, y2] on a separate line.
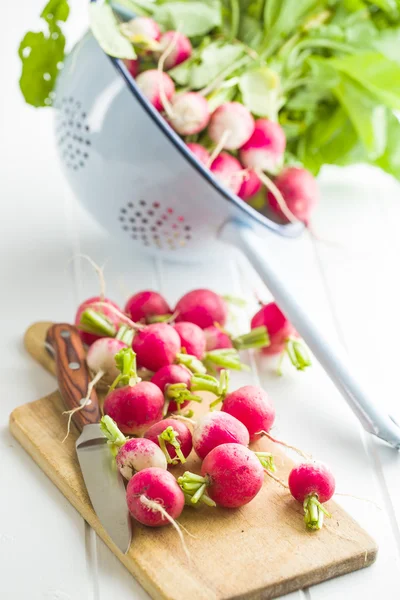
[55, 8, 400, 448]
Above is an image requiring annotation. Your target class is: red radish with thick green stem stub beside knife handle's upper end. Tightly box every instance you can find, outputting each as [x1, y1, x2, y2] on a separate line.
[75, 296, 120, 346]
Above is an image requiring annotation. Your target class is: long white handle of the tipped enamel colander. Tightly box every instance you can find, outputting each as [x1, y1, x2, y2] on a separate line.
[220, 220, 400, 450]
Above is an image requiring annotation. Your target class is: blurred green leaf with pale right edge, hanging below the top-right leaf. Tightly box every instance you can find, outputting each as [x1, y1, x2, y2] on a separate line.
[333, 75, 387, 160]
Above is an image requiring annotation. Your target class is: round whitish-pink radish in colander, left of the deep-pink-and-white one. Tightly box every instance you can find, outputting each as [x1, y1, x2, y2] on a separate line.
[208, 102, 254, 150]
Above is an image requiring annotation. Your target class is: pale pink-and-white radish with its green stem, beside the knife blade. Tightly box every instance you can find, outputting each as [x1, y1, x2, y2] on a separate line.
[100, 415, 167, 480]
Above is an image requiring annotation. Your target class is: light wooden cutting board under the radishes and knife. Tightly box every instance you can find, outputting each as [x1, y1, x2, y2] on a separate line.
[10, 323, 377, 600]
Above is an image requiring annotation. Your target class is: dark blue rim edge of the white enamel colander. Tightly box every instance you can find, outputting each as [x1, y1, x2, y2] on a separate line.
[90, 0, 304, 238]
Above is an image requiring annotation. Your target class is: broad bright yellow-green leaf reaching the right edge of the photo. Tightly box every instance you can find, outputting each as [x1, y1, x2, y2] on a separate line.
[329, 52, 400, 109]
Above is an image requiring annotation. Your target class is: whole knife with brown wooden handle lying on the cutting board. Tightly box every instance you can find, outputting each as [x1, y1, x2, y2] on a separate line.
[45, 323, 132, 554]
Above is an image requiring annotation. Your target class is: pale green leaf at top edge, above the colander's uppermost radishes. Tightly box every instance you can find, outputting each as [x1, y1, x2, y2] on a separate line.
[154, 0, 222, 37]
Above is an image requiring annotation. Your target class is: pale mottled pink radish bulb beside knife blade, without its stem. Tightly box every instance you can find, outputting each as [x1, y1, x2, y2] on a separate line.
[115, 438, 167, 481]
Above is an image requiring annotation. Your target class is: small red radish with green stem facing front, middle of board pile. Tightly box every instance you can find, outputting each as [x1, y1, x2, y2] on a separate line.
[151, 365, 201, 412]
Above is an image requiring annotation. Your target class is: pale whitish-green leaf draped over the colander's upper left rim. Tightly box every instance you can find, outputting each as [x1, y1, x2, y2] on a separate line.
[89, 2, 136, 59]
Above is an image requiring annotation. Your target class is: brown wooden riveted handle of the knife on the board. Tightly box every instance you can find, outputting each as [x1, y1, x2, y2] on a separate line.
[46, 323, 101, 431]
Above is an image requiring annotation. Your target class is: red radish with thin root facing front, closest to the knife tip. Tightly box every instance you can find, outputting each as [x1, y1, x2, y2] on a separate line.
[126, 467, 185, 527]
